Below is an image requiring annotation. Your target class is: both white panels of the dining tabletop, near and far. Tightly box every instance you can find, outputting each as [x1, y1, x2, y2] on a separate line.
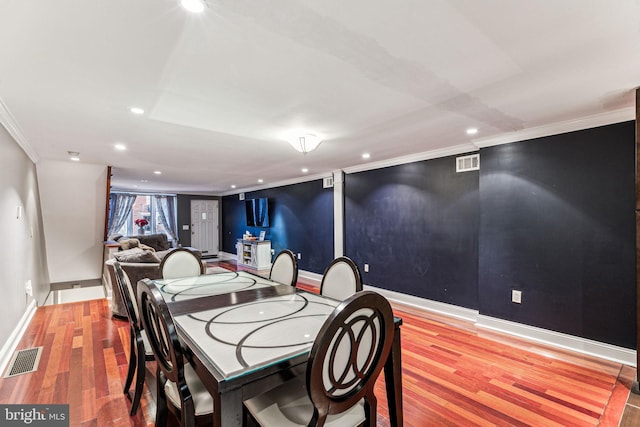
[153, 271, 339, 379]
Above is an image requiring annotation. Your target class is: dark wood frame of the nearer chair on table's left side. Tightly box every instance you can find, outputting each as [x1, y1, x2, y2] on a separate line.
[137, 281, 215, 427]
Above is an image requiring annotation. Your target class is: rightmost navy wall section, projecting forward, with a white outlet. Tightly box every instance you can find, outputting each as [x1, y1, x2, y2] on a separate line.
[479, 122, 636, 348]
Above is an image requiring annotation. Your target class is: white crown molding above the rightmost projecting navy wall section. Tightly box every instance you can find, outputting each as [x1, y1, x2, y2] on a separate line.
[471, 107, 635, 148]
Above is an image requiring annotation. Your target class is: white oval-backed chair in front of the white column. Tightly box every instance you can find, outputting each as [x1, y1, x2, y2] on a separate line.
[320, 256, 362, 300]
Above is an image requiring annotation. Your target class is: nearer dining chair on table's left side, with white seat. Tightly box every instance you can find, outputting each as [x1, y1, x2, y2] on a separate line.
[137, 280, 214, 427]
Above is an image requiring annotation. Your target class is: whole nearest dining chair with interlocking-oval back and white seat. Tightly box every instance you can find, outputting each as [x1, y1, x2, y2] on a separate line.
[244, 291, 394, 427]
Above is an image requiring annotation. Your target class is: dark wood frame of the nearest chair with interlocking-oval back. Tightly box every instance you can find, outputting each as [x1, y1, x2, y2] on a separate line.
[244, 291, 394, 427]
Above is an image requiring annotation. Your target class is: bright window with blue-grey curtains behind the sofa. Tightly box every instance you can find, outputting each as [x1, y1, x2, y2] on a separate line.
[109, 194, 176, 241]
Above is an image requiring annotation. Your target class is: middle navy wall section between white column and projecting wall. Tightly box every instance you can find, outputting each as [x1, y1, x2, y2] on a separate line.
[345, 157, 479, 309]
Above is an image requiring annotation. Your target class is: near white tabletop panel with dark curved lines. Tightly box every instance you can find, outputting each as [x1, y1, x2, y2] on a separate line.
[174, 292, 338, 379]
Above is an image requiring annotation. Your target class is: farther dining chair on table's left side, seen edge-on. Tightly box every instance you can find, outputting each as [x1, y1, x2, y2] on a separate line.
[113, 261, 155, 415]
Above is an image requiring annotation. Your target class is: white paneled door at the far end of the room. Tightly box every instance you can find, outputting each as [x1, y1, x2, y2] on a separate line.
[191, 200, 219, 257]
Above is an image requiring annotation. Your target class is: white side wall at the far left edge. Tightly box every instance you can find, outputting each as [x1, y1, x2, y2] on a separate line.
[0, 126, 50, 354]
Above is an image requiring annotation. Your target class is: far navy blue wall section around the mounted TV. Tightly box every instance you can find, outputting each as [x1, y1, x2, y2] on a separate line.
[222, 180, 334, 274]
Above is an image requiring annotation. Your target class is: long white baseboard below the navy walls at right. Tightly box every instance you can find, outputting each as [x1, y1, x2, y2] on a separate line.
[364, 285, 637, 367]
